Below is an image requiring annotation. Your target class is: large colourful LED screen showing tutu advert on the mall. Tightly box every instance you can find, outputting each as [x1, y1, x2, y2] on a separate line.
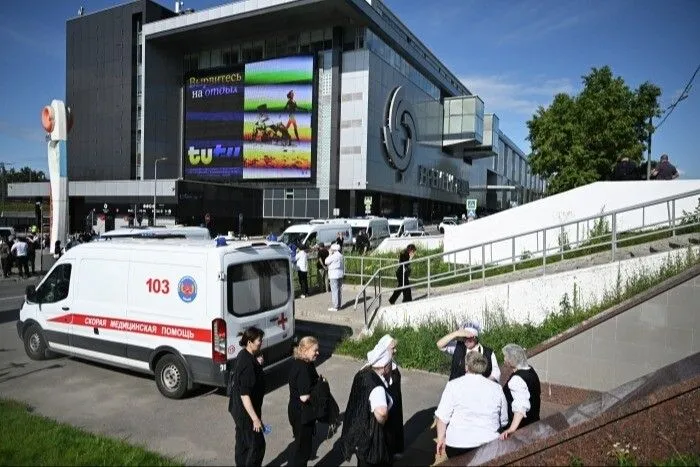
[183, 56, 315, 182]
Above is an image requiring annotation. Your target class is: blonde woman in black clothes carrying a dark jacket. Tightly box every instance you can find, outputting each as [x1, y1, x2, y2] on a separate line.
[287, 336, 319, 466]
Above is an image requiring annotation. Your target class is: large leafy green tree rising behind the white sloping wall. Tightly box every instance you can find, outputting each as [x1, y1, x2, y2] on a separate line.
[527, 66, 661, 194]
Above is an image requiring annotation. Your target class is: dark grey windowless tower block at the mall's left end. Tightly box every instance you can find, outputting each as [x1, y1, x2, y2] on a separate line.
[66, 0, 176, 181]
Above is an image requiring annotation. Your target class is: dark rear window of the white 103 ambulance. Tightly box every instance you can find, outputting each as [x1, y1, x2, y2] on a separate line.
[227, 259, 291, 316]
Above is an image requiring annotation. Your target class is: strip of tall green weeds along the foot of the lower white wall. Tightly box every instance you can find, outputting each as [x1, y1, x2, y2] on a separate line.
[336, 248, 700, 373]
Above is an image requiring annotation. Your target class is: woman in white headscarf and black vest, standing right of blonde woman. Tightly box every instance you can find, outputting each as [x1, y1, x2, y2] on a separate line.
[341, 345, 394, 465]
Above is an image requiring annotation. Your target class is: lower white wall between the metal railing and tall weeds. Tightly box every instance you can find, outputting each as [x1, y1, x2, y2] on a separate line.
[375, 247, 700, 330]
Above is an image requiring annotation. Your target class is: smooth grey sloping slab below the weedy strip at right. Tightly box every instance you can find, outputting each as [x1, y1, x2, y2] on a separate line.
[530, 276, 700, 391]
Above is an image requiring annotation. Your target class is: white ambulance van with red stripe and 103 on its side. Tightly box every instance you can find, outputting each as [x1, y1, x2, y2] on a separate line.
[17, 239, 294, 399]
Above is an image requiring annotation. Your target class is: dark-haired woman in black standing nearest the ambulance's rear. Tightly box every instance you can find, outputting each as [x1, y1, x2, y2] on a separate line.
[228, 327, 265, 466]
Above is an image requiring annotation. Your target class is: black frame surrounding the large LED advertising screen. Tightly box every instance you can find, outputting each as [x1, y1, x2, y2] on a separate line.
[179, 51, 322, 187]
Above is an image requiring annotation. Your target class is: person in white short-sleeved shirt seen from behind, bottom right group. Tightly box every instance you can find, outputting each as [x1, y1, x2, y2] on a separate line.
[435, 352, 508, 458]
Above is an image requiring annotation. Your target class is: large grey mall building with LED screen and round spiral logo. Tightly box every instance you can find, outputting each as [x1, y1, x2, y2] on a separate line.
[9, 0, 545, 233]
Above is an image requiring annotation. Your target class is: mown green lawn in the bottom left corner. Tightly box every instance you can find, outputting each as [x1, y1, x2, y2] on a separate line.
[0, 399, 182, 466]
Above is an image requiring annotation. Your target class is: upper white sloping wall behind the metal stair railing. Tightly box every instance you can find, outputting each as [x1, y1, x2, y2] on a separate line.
[444, 180, 700, 265]
